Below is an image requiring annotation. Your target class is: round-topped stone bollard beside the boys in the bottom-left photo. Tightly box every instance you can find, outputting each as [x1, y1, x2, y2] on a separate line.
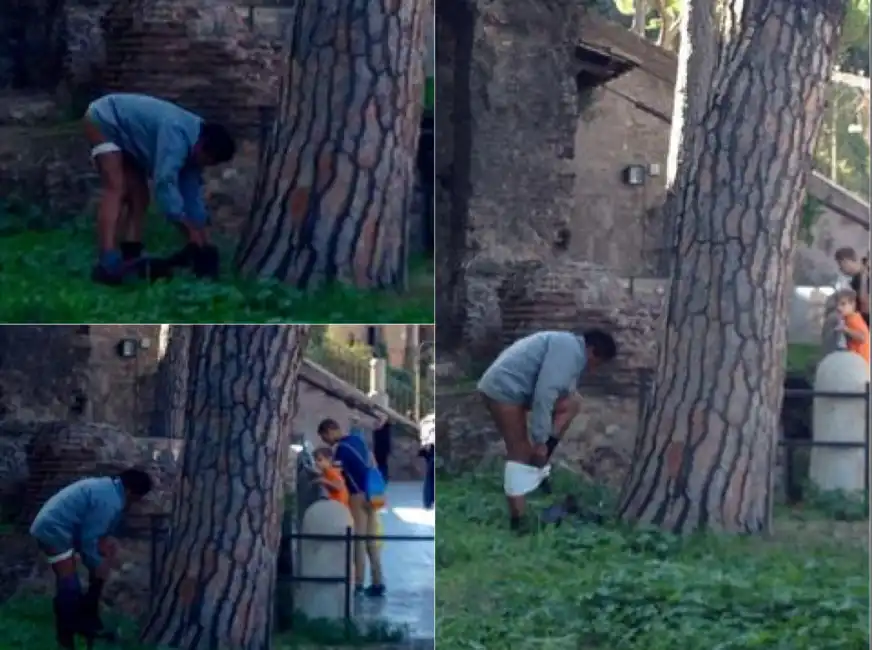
[294, 500, 353, 620]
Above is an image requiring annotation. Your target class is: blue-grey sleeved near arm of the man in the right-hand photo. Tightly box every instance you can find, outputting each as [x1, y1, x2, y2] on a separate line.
[530, 336, 584, 444]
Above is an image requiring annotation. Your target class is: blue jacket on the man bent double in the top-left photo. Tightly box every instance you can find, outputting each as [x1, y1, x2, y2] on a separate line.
[87, 93, 207, 225]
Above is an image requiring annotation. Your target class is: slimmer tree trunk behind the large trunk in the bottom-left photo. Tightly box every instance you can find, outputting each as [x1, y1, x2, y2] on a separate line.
[149, 325, 193, 438]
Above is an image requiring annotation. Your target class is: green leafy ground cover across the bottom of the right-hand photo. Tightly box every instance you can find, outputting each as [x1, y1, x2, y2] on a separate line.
[436, 473, 869, 650]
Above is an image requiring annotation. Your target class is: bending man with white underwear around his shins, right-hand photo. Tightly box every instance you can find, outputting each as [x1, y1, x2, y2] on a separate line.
[478, 330, 617, 530]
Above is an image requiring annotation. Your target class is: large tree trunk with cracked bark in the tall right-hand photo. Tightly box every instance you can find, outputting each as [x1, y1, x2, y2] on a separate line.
[619, 0, 845, 533]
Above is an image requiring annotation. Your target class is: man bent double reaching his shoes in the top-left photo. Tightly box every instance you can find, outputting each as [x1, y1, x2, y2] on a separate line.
[84, 93, 236, 284]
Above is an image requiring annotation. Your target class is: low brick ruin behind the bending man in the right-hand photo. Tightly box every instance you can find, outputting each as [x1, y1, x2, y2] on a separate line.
[437, 260, 663, 487]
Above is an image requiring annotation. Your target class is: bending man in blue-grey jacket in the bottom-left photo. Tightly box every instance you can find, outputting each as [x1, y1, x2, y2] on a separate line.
[30, 469, 152, 649]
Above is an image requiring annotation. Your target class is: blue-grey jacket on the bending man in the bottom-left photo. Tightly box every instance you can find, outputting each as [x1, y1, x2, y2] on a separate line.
[30, 478, 126, 571]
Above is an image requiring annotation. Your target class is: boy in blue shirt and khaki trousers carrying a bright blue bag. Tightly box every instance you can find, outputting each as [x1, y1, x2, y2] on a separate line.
[318, 419, 385, 597]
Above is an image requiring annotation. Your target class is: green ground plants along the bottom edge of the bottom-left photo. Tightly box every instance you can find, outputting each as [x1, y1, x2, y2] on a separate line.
[0, 597, 405, 650]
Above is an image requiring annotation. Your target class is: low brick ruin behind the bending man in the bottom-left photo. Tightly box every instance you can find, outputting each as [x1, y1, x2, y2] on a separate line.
[0, 421, 180, 618]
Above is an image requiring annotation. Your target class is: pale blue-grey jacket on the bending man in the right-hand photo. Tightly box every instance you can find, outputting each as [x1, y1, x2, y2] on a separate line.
[478, 332, 586, 443]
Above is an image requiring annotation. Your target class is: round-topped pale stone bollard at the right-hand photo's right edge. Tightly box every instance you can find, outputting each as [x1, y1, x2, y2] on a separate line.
[809, 350, 869, 494]
